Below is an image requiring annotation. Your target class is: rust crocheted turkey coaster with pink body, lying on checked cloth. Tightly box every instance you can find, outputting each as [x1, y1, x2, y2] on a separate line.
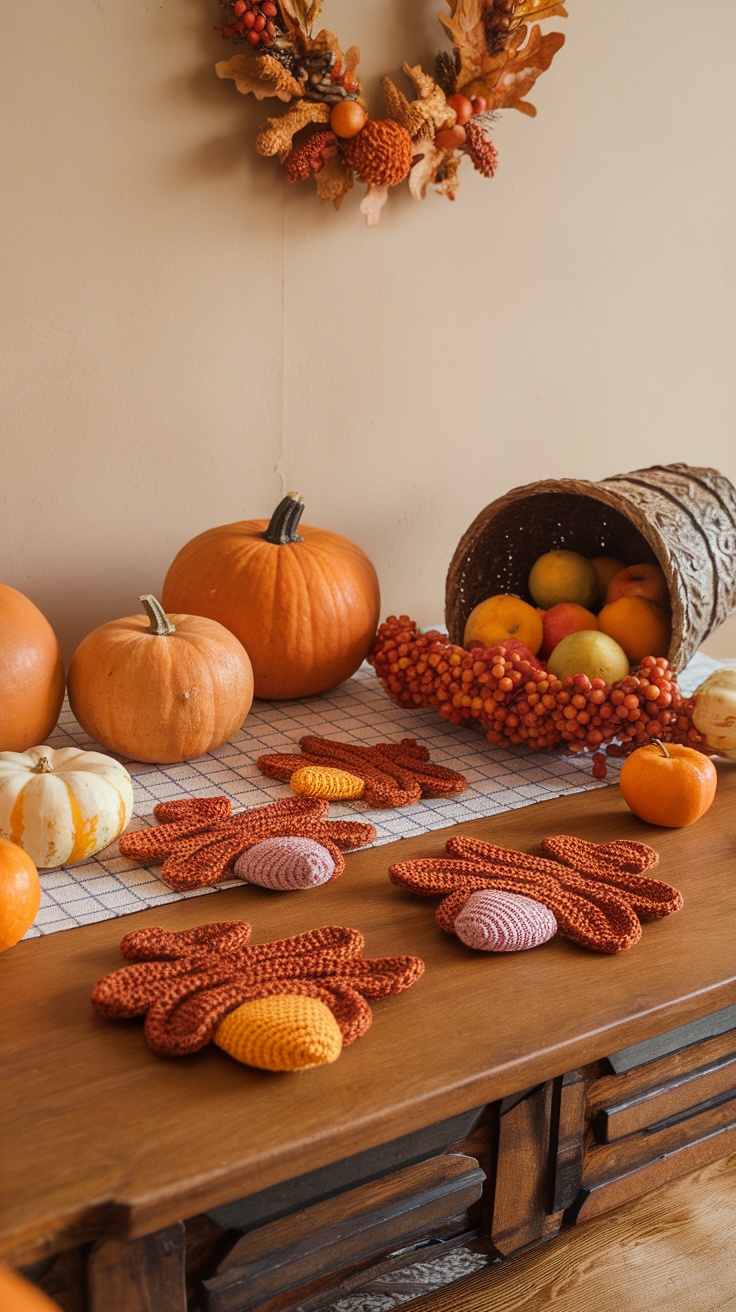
[119, 798, 375, 891]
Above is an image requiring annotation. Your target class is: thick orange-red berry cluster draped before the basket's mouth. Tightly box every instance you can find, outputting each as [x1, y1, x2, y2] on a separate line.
[369, 615, 707, 778]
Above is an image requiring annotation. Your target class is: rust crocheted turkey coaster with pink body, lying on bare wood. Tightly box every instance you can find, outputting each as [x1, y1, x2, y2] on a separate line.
[388, 836, 682, 953]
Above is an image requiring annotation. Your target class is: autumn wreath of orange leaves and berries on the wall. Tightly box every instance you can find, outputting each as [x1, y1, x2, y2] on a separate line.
[216, 0, 565, 226]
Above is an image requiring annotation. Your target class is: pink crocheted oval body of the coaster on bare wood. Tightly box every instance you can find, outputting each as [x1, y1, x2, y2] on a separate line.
[454, 888, 558, 953]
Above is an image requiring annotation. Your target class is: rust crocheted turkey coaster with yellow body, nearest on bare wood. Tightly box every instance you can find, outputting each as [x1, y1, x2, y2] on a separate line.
[92, 921, 424, 1071]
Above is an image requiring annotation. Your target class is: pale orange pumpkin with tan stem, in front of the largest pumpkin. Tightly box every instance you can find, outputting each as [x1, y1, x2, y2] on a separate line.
[68, 596, 253, 762]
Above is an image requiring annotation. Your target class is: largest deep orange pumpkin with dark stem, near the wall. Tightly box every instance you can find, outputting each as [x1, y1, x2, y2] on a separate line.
[163, 492, 380, 699]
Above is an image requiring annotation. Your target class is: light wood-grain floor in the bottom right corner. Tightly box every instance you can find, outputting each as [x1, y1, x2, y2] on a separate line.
[401, 1157, 736, 1312]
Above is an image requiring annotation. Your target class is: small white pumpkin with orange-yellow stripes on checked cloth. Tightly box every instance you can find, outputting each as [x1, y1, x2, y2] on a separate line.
[0, 747, 133, 870]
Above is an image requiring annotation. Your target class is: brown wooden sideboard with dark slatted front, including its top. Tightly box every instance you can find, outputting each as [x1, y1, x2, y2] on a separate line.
[0, 762, 736, 1312]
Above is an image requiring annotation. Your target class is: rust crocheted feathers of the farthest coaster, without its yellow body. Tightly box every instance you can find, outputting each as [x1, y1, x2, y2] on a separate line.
[257, 736, 467, 807]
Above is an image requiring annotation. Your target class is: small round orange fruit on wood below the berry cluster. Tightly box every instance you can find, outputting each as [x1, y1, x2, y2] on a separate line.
[618, 740, 718, 829]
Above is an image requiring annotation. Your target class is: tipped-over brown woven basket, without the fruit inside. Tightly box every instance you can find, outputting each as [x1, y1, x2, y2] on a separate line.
[445, 464, 736, 669]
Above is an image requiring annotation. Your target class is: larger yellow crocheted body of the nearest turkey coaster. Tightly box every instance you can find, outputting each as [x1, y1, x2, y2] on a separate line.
[214, 993, 342, 1071]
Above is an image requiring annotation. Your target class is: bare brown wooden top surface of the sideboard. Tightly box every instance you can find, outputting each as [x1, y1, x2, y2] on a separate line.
[0, 762, 736, 1262]
